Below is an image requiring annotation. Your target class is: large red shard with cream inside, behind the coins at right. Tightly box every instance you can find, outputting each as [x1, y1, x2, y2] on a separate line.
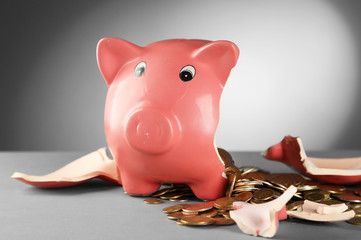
[263, 136, 361, 184]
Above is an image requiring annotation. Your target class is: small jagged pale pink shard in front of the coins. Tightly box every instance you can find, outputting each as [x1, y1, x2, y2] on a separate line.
[230, 186, 297, 237]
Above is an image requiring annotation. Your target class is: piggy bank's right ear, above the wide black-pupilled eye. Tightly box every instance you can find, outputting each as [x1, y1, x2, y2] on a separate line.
[193, 41, 239, 86]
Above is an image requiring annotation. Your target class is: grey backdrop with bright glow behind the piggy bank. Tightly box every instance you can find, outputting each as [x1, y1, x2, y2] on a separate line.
[0, 0, 361, 151]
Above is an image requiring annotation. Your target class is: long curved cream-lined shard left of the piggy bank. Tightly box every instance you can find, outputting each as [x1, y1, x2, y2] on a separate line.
[11, 148, 121, 188]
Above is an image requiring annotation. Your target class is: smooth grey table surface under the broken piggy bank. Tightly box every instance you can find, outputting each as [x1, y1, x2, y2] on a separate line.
[0, 151, 361, 240]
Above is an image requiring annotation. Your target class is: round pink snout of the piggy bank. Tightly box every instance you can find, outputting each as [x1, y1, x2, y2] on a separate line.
[125, 108, 178, 154]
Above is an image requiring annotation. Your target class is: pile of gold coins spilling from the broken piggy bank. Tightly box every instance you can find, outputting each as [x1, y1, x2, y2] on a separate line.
[144, 149, 361, 226]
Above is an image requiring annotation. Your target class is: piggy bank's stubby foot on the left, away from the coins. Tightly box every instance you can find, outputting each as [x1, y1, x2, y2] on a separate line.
[120, 172, 161, 196]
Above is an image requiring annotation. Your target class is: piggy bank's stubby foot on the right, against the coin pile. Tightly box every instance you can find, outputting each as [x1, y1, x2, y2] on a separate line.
[189, 176, 227, 200]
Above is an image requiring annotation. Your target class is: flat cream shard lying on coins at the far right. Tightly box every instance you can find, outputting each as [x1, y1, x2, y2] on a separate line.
[287, 200, 355, 222]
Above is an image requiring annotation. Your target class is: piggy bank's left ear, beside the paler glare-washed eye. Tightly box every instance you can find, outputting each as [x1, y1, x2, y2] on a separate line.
[97, 38, 142, 86]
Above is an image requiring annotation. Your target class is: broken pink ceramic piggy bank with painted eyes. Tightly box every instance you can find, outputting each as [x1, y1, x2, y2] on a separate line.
[97, 38, 239, 200]
